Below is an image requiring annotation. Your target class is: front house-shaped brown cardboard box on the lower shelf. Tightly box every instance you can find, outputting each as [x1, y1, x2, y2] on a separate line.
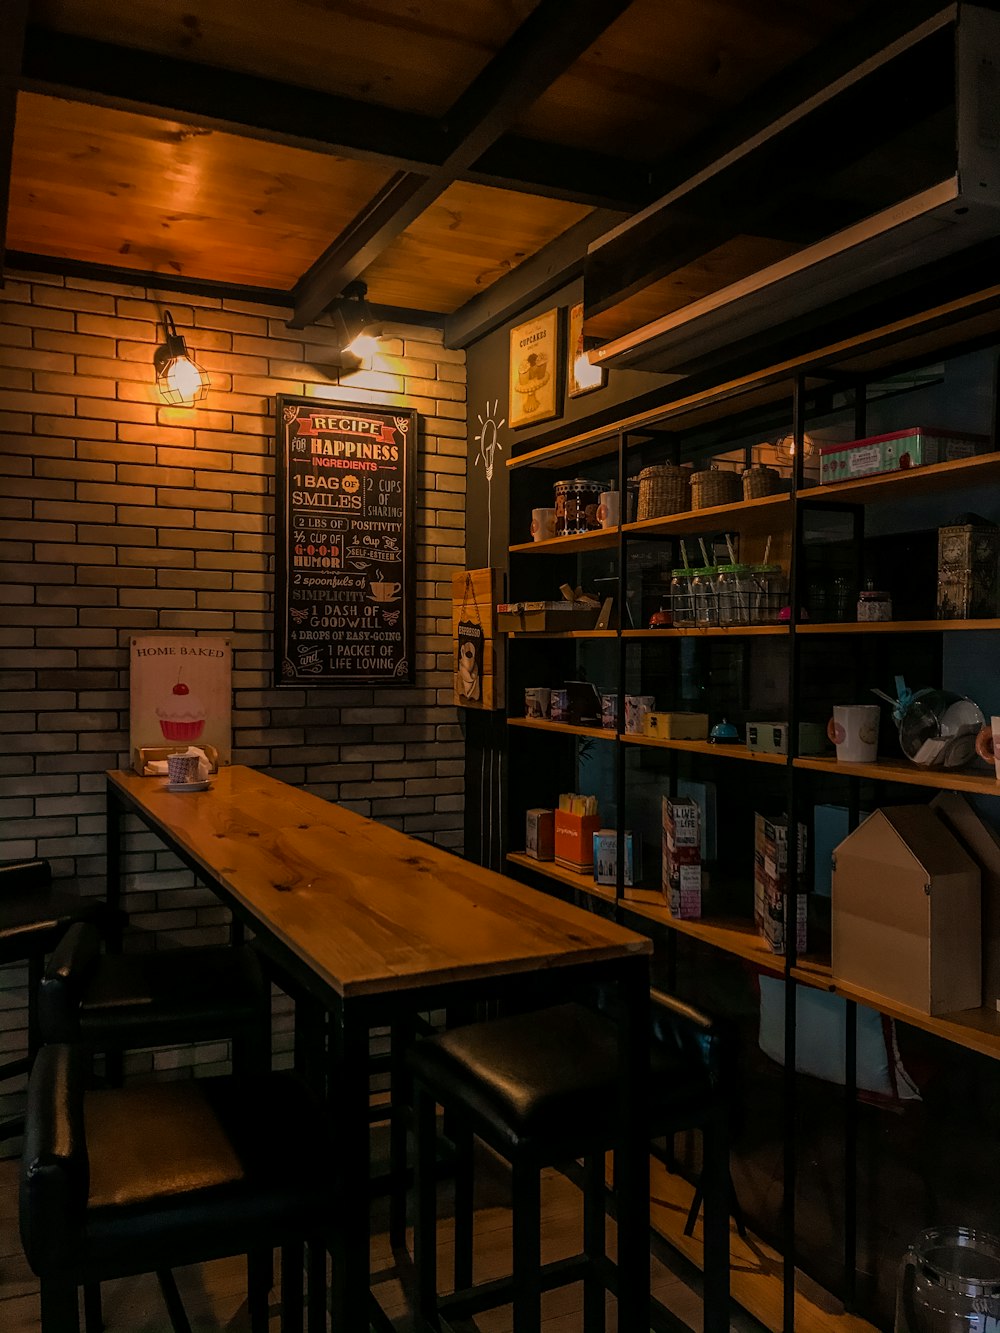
[832, 805, 983, 1014]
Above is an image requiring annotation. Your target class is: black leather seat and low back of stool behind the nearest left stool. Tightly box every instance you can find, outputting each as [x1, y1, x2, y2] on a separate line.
[39, 924, 269, 1050]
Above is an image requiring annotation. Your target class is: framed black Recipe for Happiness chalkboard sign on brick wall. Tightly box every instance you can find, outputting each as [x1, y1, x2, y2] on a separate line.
[275, 393, 417, 688]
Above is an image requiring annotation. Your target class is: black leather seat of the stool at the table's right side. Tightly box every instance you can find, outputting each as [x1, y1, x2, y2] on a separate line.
[411, 1004, 711, 1150]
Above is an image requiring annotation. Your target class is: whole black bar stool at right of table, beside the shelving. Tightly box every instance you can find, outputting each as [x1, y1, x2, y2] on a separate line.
[409, 990, 729, 1333]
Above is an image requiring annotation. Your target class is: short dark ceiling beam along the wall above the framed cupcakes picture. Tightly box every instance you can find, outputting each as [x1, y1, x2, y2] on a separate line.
[444, 209, 625, 348]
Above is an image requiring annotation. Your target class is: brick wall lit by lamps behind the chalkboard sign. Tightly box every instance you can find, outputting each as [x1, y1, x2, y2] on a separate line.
[0, 273, 465, 1135]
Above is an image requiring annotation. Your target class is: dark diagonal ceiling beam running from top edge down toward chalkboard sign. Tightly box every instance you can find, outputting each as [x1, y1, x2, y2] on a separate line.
[289, 0, 631, 328]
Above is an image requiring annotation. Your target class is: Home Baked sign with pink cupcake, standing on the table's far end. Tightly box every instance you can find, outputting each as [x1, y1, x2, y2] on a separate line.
[128, 635, 232, 773]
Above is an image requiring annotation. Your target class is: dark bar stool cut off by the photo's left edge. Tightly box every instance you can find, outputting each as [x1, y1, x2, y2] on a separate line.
[0, 857, 127, 1140]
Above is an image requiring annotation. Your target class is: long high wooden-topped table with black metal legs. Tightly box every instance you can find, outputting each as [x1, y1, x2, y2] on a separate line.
[107, 765, 652, 1333]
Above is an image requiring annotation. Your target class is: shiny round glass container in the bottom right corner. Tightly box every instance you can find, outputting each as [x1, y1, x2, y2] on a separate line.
[895, 1226, 1000, 1333]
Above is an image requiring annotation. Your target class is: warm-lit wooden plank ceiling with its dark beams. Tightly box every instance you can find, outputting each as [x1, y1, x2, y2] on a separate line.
[0, 0, 885, 341]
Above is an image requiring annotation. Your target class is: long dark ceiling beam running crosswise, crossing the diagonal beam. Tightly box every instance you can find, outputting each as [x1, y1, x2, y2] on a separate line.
[21, 24, 641, 208]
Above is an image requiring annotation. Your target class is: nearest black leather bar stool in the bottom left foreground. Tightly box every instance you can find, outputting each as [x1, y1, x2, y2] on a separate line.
[20, 1045, 333, 1333]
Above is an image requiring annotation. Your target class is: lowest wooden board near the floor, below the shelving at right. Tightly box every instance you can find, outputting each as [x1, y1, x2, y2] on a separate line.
[649, 1157, 876, 1333]
